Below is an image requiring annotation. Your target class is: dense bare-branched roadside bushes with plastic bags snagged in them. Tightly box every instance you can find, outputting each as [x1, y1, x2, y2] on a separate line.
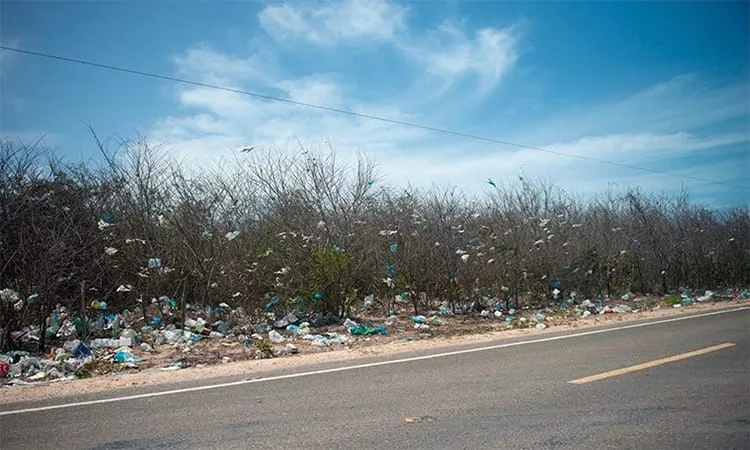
[0, 135, 750, 351]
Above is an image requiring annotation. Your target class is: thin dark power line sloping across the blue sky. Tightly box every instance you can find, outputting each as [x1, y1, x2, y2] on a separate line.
[0, 45, 750, 189]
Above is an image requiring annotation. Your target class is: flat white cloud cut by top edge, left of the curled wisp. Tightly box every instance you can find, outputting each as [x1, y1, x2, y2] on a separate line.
[258, 0, 407, 45]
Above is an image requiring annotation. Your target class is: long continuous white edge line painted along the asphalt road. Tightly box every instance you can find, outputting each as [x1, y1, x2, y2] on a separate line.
[0, 306, 750, 417]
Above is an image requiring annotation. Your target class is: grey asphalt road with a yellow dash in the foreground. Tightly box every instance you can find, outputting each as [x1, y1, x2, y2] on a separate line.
[0, 309, 750, 449]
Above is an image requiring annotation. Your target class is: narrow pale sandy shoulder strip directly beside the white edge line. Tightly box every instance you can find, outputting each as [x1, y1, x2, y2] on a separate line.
[0, 299, 750, 404]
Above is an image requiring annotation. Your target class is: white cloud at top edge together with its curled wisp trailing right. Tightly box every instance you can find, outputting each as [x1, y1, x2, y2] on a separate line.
[258, 0, 519, 98]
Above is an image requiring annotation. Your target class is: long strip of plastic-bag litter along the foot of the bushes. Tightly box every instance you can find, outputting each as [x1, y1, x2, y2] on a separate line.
[0, 287, 750, 386]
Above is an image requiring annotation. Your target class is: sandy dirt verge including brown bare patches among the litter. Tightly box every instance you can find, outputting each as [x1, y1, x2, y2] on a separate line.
[0, 299, 750, 404]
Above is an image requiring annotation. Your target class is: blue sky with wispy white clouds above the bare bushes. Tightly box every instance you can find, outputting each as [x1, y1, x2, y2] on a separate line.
[0, 0, 750, 206]
